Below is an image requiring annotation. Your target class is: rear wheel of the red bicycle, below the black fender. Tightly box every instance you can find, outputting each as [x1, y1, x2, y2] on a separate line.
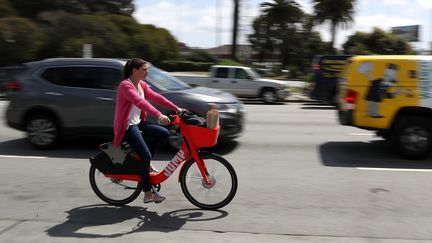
[89, 165, 142, 206]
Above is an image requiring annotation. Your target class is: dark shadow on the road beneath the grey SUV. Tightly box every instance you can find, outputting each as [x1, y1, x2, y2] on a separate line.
[0, 138, 239, 161]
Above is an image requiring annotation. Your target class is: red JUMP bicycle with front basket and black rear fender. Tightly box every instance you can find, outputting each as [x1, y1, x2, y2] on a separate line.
[89, 112, 237, 209]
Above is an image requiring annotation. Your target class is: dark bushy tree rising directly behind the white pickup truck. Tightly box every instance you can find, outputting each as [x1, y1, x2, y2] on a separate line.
[249, 1, 328, 77]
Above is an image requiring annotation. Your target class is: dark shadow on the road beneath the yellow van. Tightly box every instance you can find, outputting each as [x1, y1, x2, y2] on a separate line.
[320, 140, 432, 169]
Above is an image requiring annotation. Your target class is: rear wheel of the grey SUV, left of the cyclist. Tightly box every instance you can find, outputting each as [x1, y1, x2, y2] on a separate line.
[26, 114, 60, 149]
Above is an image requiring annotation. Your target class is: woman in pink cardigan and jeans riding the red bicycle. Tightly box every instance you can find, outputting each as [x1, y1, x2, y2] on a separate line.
[113, 58, 183, 203]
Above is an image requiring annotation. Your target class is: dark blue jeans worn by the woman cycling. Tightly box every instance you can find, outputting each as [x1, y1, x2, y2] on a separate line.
[123, 121, 169, 192]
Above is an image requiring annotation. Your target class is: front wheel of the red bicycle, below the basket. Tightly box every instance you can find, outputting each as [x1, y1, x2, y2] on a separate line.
[180, 152, 238, 209]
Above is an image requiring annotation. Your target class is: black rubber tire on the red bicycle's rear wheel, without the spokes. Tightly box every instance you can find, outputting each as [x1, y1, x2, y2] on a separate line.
[89, 165, 142, 206]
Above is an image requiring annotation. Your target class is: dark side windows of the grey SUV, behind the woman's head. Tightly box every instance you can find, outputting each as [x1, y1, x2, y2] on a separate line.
[41, 67, 122, 89]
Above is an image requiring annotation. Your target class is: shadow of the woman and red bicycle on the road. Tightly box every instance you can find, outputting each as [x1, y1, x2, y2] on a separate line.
[46, 205, 228, 238]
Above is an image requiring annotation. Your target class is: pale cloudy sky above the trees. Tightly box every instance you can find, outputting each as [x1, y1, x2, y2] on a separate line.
[133, 0, 432, 50]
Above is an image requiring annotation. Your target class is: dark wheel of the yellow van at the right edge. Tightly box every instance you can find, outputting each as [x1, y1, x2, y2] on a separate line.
[393, 117, 432, 159]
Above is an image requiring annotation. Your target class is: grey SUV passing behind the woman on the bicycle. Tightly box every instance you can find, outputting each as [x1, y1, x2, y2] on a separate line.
[6, 58, 244, 148]
